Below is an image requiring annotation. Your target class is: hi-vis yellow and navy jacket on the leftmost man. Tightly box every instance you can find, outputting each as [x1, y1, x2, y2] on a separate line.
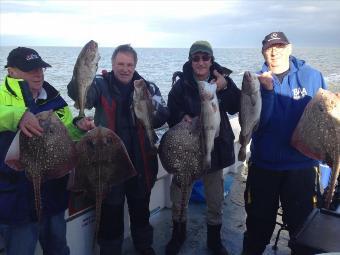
[0, 76, 83, 224]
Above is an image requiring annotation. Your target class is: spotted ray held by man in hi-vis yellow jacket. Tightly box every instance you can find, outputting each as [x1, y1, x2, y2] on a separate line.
[6, 111, 75, 219]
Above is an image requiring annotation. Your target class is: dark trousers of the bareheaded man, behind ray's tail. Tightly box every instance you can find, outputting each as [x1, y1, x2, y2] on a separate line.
[98, 177, 153, 255]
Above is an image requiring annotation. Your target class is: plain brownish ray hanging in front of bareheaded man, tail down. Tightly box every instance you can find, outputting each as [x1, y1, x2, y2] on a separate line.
[71, 127, 137, 247]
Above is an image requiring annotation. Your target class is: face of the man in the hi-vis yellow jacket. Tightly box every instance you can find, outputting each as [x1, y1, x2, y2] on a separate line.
[9, 67, 45, 91]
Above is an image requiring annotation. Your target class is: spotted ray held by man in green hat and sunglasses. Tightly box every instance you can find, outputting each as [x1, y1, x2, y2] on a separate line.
[158, 117, 205, 222]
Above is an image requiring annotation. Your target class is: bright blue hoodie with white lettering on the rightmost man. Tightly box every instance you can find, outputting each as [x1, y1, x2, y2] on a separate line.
[251, 56, 326, 171]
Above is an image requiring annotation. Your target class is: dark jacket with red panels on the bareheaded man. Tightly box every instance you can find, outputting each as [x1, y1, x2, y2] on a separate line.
[68, 72, 169, 191]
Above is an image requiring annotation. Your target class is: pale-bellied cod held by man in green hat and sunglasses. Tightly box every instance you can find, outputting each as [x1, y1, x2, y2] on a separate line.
[198, 81, 221, 169]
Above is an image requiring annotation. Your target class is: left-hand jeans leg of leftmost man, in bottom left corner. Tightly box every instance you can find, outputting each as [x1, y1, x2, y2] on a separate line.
[0, 220, 38, 255]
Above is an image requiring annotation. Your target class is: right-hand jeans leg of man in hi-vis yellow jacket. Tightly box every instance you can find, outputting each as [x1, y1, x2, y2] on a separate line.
[39, 212, 70, 255]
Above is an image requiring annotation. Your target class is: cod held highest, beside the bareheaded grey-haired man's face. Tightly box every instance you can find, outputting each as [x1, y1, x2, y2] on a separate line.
[72, 40, 100, 117]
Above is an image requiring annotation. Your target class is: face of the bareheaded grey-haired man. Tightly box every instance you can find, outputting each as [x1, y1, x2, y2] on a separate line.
[112, 52, 136, 84]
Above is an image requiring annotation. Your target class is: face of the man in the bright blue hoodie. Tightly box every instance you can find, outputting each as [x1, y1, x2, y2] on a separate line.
[262, 44, 292, 70]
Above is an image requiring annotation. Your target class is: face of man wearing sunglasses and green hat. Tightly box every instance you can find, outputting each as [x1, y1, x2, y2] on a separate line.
[191, 52, 212, 81]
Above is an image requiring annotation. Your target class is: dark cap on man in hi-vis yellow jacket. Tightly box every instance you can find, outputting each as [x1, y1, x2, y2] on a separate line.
[5, 47, 51, 72]
